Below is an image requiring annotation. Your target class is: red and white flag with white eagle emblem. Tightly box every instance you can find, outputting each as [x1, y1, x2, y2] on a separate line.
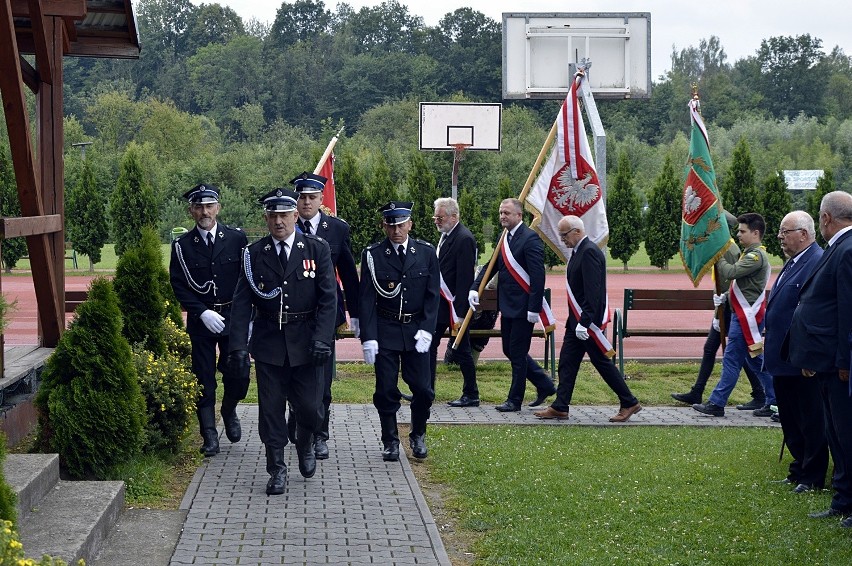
[526, 71, 609, 261]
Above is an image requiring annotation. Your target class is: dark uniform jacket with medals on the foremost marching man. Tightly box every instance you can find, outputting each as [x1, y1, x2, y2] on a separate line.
[230, 232, 337, 370]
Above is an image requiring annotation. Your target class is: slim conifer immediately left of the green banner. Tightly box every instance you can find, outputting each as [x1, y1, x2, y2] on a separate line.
[645, 155, 682, 269]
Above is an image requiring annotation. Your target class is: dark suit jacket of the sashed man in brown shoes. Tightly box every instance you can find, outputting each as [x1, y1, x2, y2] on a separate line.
[565, 238, 606, 330]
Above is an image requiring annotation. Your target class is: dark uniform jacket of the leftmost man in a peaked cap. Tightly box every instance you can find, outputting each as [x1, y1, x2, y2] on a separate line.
[169, 223, 248, 337]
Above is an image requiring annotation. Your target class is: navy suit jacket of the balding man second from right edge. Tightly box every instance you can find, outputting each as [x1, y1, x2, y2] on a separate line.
[763, 242, 822, 375]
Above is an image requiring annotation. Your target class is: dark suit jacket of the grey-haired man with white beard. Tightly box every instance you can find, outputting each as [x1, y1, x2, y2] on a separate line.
[438, 222, 476, 325]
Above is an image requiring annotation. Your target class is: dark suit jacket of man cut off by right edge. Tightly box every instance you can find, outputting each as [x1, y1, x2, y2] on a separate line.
[788, 231, 852, 372]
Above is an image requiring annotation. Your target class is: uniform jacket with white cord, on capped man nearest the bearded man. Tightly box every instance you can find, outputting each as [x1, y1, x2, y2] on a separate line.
[359, 238, 441, 351]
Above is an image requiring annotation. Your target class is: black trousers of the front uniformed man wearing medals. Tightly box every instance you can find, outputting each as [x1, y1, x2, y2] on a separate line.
[255, 360, 323, 448]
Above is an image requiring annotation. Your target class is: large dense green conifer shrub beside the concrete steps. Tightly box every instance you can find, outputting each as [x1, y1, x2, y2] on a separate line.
[35, 277, 145, 479]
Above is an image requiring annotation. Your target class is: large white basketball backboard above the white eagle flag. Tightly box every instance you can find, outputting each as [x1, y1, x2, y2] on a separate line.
[503, 12, 651, 99]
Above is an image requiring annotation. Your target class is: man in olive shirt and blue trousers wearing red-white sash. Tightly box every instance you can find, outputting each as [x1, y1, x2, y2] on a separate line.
[692, 212, 775, 417]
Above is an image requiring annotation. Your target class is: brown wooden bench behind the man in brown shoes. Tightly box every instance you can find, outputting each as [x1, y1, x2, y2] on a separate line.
[612, 289, 713, 375]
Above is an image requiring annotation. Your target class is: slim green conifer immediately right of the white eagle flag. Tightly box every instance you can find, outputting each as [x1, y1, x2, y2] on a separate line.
[606, 151, 642, 271]
